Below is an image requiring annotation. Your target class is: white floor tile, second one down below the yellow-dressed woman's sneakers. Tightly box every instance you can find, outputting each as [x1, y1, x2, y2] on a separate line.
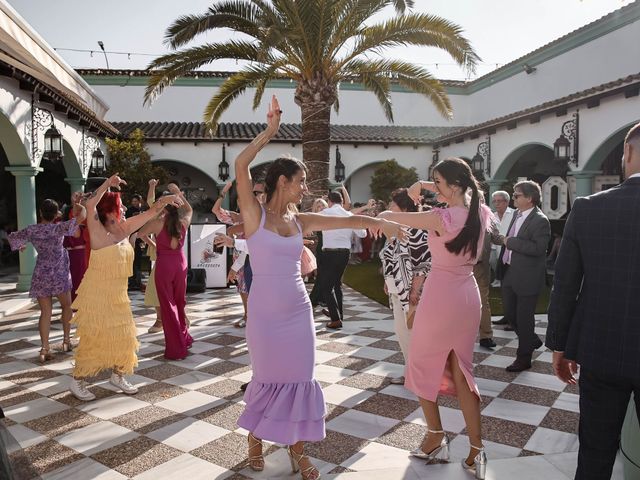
[56, 421, 139, 456]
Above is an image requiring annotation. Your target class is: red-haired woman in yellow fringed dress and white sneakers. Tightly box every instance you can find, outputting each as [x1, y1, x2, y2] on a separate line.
[70, 174, 182, 402]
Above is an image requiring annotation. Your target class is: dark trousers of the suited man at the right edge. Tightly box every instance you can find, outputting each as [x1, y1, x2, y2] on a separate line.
[575, 368, 640, 480]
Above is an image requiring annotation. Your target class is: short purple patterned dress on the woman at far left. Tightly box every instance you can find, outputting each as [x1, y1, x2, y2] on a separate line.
[9, 218, 77, 298]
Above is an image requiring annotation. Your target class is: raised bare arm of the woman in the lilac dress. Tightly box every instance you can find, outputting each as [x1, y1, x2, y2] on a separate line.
[235, 95, 282, 237]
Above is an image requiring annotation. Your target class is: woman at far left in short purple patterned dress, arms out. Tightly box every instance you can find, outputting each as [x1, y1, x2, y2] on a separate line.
[9, 199, 86, 362]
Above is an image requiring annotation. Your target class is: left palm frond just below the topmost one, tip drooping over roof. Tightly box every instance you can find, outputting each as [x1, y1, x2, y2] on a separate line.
[144, 40, 274, 104]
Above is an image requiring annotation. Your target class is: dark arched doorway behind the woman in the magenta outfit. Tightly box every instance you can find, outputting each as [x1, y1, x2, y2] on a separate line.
[153, 160, 219, 223]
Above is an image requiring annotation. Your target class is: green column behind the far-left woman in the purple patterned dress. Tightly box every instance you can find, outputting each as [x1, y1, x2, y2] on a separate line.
[6, 166, 42, 292]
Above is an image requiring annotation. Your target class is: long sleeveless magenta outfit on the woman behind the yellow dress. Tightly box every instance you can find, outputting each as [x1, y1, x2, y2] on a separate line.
[155, 226, 193, 360]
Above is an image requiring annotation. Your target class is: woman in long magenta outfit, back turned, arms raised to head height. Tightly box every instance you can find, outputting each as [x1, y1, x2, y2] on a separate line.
[139, 184, 193, 360]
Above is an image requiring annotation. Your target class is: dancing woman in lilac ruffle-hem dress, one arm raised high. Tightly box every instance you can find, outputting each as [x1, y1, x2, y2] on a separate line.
[235, 97, 405, 480]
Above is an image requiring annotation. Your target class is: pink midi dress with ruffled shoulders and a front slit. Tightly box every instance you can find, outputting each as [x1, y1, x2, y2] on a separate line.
[405, 207, 488, 402]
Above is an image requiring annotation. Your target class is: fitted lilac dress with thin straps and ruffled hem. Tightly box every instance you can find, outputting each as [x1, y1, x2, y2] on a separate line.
[238, 209, 325, 445]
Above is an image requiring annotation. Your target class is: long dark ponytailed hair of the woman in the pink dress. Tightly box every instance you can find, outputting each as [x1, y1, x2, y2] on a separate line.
[433, 158, 482, 258]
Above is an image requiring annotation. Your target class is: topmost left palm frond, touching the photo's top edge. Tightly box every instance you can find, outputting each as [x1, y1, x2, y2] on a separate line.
[164, 0, 263, 49]
